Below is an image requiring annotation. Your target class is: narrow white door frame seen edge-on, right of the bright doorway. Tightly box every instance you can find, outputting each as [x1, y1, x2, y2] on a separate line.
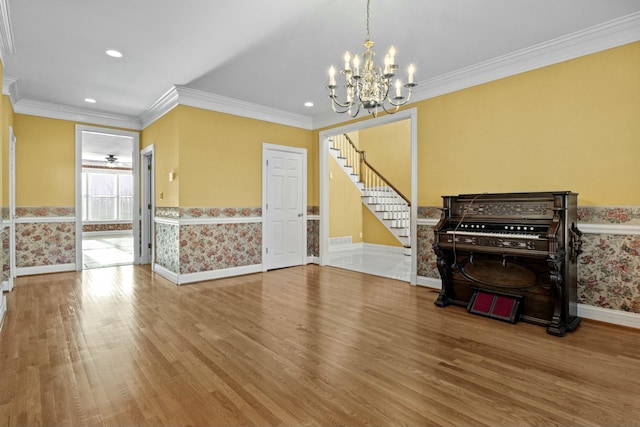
[140, 144, 156, 268]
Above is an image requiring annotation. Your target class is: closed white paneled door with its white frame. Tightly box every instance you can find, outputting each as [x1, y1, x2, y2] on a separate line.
[262, 144, 307, 271]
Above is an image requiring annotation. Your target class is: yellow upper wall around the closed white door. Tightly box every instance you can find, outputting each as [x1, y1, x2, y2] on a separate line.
[176, 106, 317, 207]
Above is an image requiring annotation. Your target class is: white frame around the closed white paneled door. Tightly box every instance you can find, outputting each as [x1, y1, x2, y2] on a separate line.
[262, 142, 308, 271]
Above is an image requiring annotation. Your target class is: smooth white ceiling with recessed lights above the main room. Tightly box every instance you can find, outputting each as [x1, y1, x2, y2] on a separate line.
[0, 0, 640, 130]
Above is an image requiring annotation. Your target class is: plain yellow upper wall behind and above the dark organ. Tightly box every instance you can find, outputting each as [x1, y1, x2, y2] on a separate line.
[418, 42, 640, 206]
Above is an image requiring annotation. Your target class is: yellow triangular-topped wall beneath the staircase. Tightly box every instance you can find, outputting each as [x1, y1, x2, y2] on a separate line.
[328, 156, 366, 243]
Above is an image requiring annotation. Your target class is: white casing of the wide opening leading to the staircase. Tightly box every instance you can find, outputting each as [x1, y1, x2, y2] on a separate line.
[319, 108, 418, 285]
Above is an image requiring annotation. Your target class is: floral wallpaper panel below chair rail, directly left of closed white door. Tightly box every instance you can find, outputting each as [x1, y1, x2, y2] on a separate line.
[180, 223, 262, 274]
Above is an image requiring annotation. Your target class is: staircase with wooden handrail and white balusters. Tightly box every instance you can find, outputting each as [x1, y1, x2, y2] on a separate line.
[329, 134, 411, 254]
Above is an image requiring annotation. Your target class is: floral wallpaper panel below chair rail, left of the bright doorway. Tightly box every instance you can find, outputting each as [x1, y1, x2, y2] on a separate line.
[16, 222, 76, 268]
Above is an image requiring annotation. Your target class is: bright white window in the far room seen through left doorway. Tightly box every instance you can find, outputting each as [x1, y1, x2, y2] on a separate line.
[82, 169, 133, 222]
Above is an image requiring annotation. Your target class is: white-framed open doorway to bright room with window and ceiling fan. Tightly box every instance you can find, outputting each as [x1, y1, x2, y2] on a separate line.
[76, 125, 140, 270]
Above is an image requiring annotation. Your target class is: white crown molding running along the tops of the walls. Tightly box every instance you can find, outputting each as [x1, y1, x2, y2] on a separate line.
[0, 12, 640, 130]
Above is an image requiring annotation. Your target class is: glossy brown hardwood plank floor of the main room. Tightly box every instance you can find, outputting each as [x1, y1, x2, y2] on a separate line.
[0, 265, 640, 426]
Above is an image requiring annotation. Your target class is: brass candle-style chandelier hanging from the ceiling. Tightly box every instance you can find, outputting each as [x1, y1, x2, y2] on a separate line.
[327, 0, 417, 117]
